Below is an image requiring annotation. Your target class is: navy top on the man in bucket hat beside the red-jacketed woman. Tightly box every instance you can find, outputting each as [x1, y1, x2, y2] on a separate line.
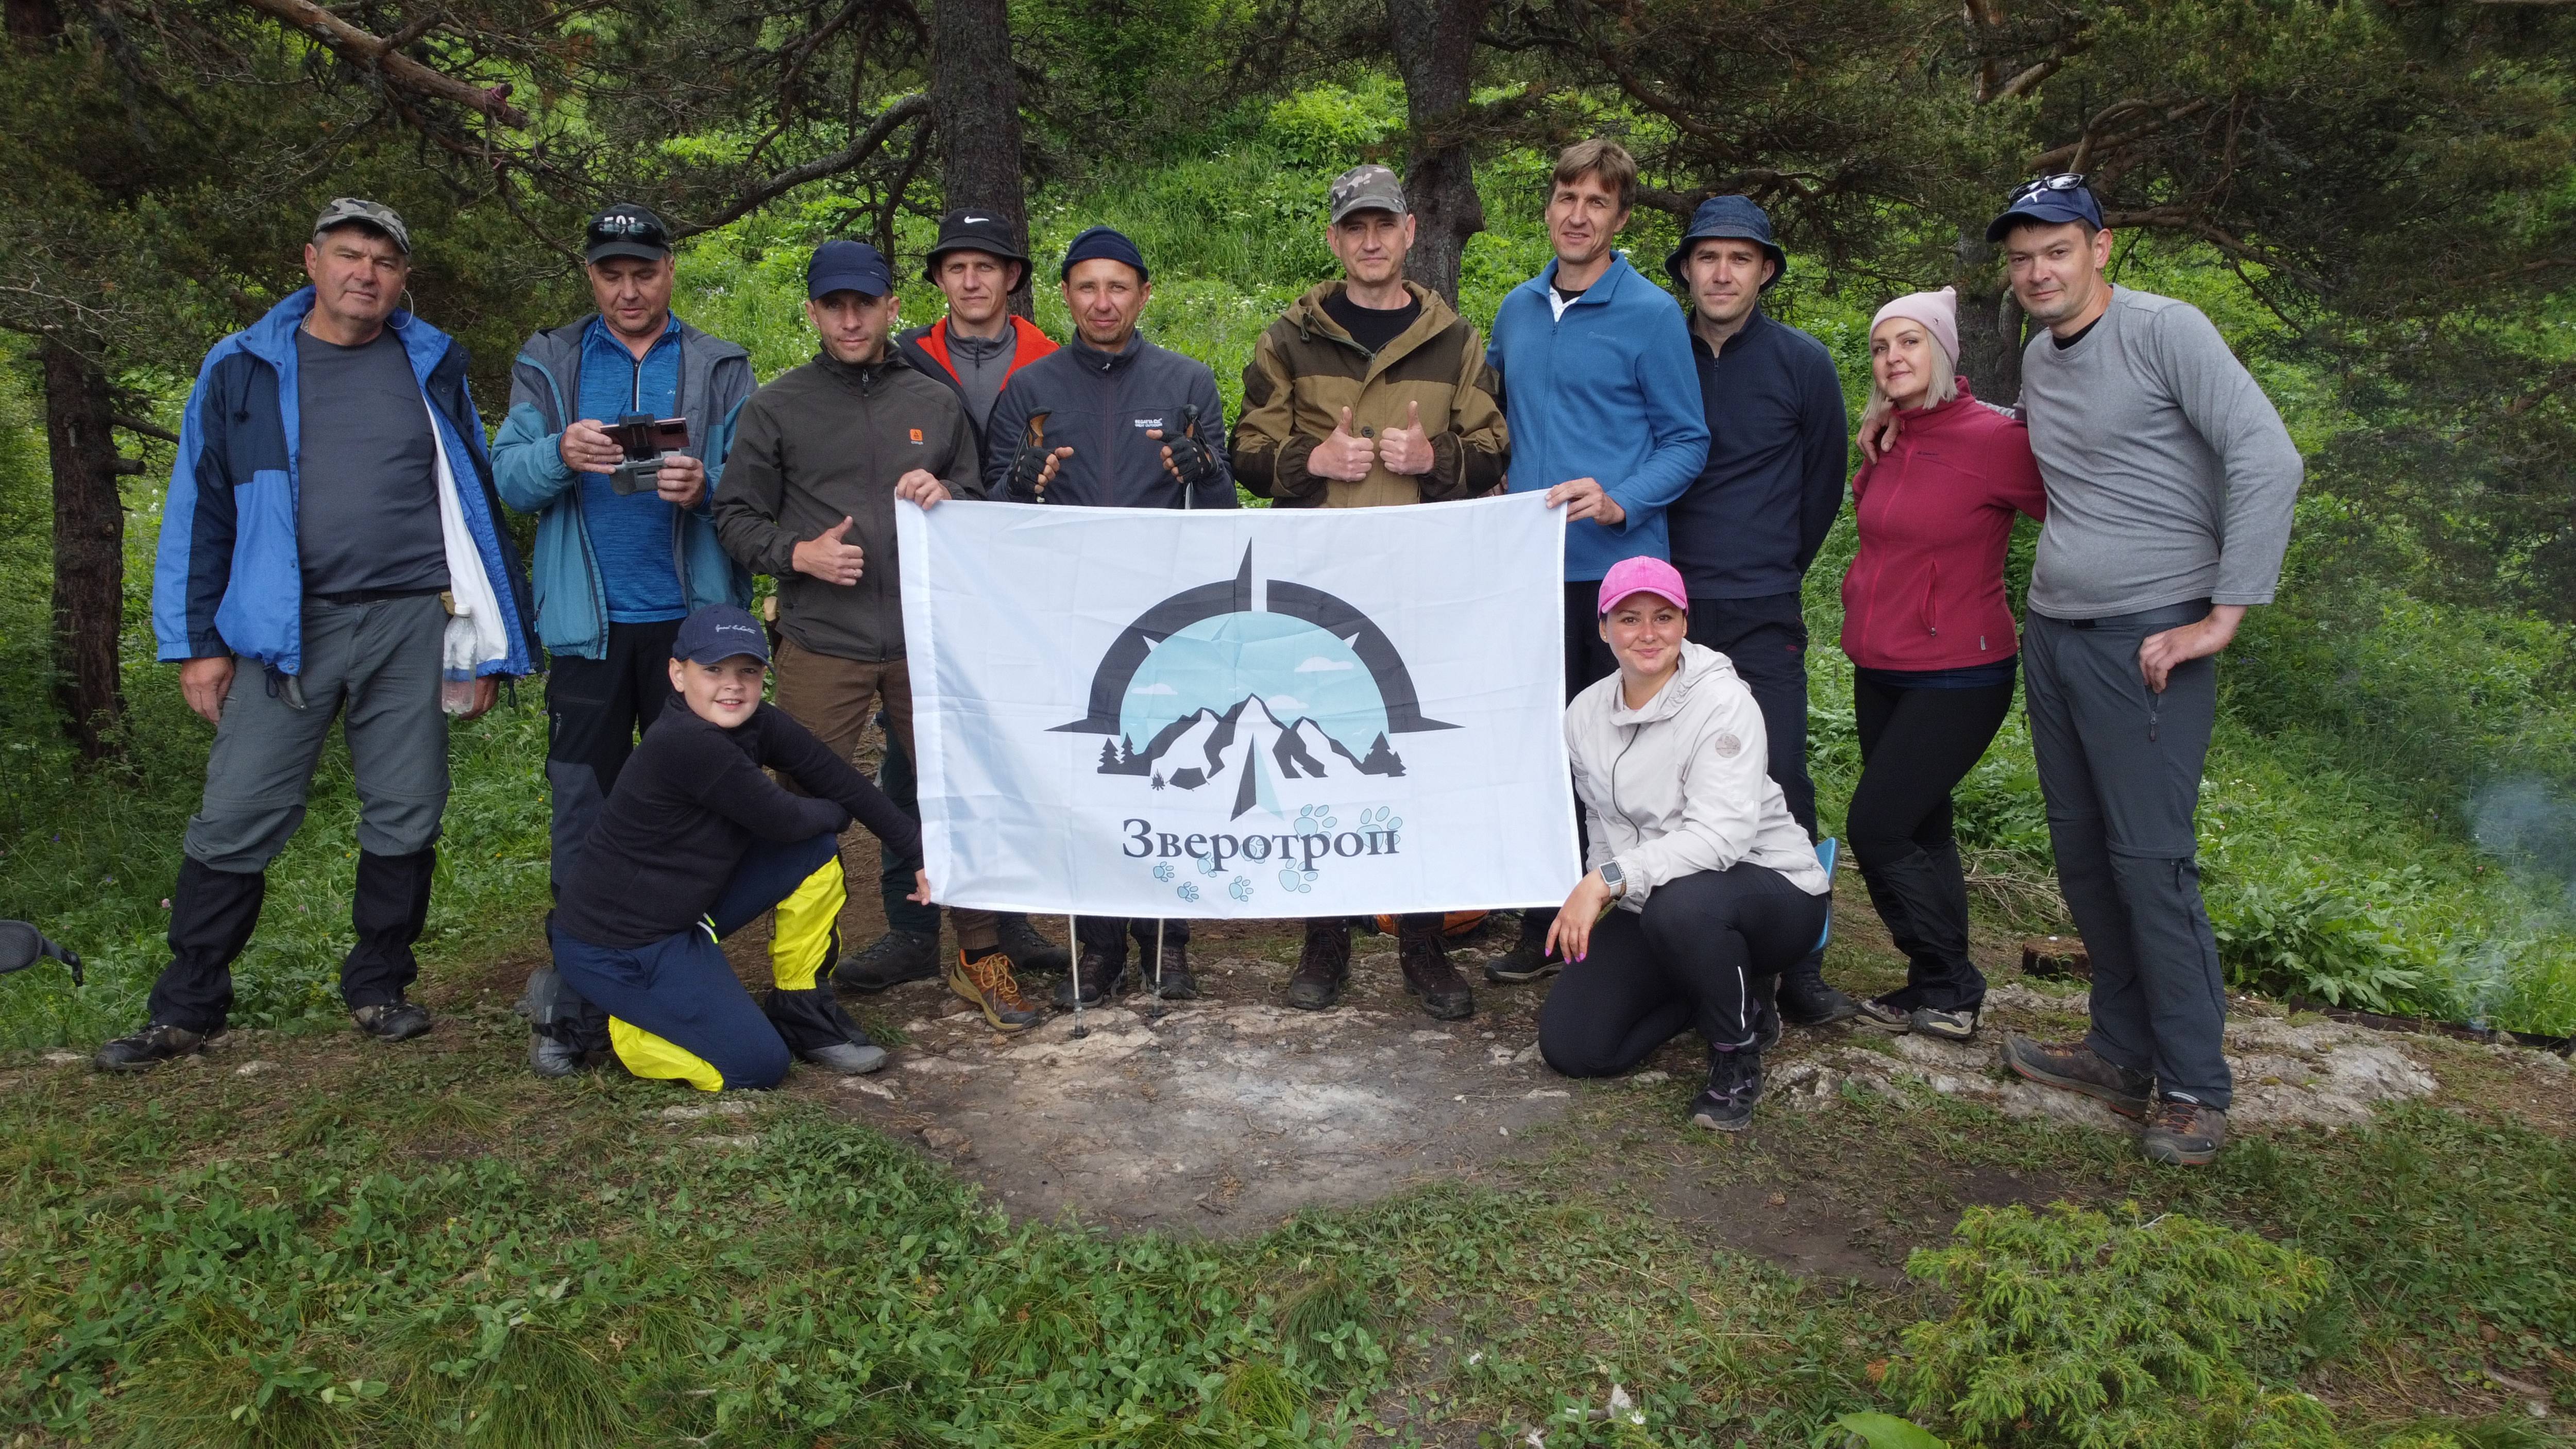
[1664, 307, 1852, 598]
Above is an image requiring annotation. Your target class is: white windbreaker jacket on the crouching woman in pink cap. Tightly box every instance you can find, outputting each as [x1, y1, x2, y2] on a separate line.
[1566, 642, 1832, 910]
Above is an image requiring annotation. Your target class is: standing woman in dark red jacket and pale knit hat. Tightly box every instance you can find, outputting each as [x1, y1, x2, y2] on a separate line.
[1842, 286, 2048, 1039]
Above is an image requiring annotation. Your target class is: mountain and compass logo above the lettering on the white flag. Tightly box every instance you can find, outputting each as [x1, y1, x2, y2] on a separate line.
[1056, 549, 1455, 817]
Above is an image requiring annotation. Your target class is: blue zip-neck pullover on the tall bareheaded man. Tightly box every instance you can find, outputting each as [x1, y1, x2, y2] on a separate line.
[1484, 255, 1708, 580]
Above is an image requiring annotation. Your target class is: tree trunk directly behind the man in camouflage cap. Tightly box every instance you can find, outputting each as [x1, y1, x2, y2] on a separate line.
[1386, 0, 1486, 307]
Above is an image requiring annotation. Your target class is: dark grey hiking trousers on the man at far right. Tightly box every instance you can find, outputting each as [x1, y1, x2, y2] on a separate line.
[2022, 601, 2233, 1111]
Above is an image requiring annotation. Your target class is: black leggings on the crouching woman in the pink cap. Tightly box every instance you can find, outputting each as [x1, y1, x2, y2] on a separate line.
[1538, 861, 1824, 1077]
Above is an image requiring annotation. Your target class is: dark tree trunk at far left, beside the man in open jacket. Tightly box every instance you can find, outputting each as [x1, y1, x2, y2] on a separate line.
[39, 340, 126, 761]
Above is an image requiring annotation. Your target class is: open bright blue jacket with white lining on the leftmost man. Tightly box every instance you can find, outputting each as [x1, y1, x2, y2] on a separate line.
[152, 286, 536, 676]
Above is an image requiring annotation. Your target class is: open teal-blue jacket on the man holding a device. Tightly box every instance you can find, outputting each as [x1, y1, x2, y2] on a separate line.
[492, 317, 755, 660]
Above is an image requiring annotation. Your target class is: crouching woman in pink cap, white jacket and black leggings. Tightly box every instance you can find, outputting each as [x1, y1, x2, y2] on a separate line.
[1538, 557, 1832, 1132]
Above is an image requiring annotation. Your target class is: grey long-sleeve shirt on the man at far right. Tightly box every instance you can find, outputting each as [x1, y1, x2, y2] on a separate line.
[2022, 286, 2306, 619]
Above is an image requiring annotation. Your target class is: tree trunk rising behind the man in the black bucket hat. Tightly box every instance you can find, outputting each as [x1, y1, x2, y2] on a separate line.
[930, 0, 1036, 317]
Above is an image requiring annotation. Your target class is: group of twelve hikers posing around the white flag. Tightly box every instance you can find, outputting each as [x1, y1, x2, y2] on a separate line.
[98, 139, 2300, 1163]
